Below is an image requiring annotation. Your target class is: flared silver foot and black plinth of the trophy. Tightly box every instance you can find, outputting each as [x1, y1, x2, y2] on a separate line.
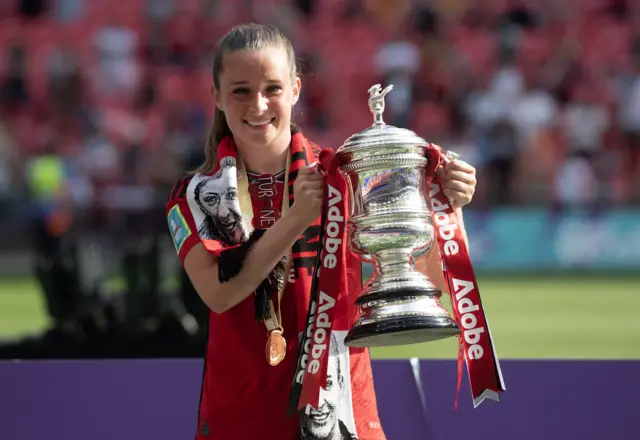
[345, 288, 460, 347]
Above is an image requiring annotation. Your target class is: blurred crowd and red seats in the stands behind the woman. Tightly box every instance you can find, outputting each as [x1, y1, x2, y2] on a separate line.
[0, 0, 640, 213]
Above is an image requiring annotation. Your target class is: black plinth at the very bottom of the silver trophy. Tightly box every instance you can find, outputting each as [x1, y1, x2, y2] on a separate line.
[344, 316, 460, 348]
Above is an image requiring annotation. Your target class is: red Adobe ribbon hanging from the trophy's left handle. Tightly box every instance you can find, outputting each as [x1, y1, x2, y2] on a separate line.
[288, 150, 348, 416]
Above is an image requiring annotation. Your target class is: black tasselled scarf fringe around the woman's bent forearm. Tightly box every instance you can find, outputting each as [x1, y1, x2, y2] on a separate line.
[218, 229, 286, 321]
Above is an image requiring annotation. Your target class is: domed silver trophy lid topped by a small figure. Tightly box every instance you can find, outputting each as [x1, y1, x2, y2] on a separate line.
[336, 84, 428, 156]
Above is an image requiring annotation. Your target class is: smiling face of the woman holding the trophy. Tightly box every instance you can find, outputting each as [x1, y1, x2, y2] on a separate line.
[213, 48, 300, 154]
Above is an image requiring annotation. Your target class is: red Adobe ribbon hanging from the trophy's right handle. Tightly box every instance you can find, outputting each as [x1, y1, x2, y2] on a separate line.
[426, 144, 506, 408]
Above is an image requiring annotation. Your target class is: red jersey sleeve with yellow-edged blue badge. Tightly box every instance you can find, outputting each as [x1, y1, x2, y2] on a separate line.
[165, 178, 200, 264]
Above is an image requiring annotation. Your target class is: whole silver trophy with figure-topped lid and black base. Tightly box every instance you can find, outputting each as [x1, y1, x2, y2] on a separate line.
[337, 84, 460, 347]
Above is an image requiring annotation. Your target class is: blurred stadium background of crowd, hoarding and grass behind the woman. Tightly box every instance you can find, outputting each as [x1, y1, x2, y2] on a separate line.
[0, 0, 640, 359]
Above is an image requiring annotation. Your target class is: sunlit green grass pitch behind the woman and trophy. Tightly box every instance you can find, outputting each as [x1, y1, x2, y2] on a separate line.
[0, 276, 640, 359]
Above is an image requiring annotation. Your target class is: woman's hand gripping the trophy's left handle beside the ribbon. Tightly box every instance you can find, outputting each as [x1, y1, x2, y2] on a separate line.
[290, 165, 324, 227]
